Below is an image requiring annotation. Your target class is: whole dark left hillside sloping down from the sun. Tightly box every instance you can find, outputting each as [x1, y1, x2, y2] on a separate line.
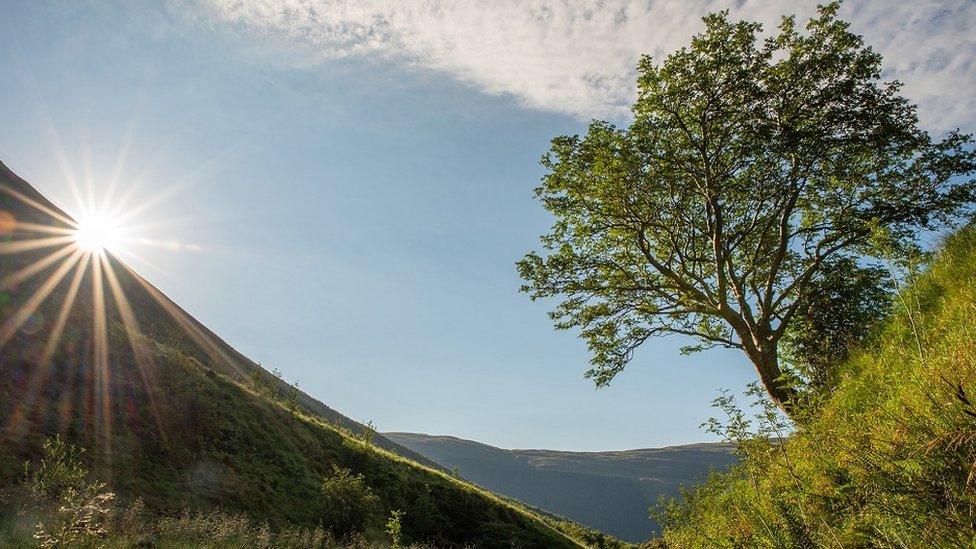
[0, 161, 612, 547]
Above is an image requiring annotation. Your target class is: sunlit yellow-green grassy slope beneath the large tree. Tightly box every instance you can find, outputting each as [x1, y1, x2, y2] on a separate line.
[663, 227, 976, 547]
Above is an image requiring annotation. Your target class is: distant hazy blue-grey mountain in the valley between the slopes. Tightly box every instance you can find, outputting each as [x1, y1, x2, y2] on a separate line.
[384, 433, 735, 543]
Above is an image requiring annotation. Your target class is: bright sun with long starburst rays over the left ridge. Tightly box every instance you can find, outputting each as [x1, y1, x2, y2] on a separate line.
[0, 164, 242, 474]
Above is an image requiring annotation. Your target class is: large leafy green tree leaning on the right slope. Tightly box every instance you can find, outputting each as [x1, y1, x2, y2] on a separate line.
[518, 3, 976, 413]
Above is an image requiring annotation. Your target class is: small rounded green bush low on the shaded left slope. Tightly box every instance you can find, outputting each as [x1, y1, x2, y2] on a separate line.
[322, 465, 379, 536]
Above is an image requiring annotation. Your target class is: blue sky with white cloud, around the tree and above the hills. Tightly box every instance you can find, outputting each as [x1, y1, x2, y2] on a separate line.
[0, 0, 976, 450]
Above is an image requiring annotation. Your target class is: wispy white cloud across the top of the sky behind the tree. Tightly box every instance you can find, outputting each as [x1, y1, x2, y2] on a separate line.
[200, 0, 976, 130]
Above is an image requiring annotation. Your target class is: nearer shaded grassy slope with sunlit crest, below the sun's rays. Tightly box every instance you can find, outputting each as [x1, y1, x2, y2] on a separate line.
[0, 316, 619, 547]
